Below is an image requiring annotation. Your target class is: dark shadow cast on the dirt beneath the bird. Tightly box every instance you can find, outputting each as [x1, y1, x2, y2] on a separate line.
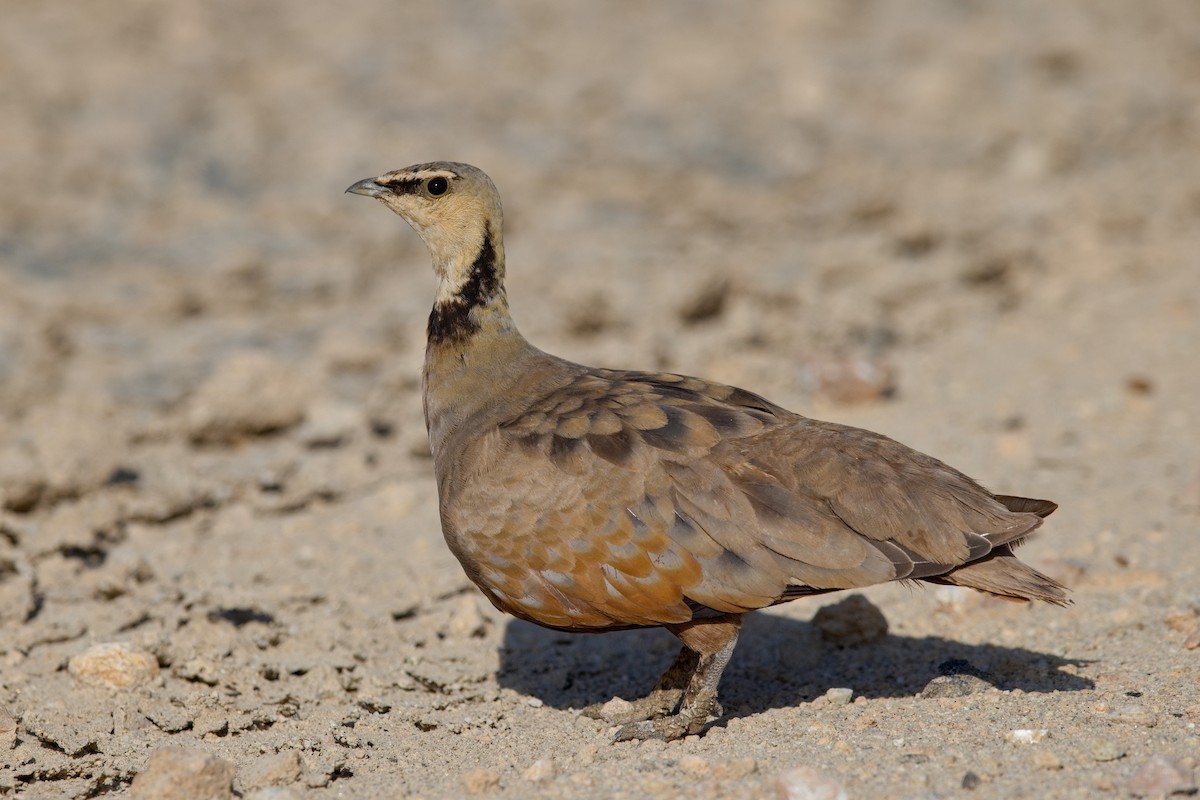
[498, 606, 1094, 716]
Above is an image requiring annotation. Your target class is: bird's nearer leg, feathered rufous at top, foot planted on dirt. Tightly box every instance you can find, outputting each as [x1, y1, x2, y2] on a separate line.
[614, 614, 742, 741]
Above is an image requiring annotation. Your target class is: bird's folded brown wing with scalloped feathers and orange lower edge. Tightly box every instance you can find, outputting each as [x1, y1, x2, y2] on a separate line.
[446, 371, 1039, 628]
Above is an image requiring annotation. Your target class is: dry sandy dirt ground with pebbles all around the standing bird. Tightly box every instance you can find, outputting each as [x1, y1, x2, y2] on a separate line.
[0, 0, 1200, 800]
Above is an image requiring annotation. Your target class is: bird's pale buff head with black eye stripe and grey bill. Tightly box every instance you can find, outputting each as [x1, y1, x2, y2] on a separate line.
[346, 161, 503, 279]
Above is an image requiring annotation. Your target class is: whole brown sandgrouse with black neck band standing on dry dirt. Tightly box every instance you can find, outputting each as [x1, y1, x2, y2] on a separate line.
[346, 162, 1070, 741]
